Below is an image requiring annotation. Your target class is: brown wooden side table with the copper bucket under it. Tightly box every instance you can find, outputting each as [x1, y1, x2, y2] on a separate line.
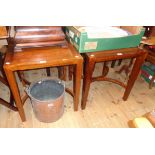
[3, 44, 83, 121]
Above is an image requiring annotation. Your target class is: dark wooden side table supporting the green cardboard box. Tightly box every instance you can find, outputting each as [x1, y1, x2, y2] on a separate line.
[81, 48, 147, 109]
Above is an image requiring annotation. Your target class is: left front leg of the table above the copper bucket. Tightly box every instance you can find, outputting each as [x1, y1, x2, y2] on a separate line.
[4, 68, 26, 122]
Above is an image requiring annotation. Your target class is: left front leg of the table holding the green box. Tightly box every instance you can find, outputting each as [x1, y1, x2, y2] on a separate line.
[81, 57, 95, 109]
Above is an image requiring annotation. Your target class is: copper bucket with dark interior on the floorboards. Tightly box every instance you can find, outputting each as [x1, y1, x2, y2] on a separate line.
[26, 79, 65, 123]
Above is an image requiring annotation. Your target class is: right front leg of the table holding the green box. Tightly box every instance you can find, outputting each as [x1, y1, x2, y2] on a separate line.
[123, 51, 147, 101]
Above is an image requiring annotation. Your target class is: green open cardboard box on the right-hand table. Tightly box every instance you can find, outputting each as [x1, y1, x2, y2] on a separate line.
[65, 26, 145, 53]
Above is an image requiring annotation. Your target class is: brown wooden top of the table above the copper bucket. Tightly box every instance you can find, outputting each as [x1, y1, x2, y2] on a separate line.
[4, 44, 82, 70]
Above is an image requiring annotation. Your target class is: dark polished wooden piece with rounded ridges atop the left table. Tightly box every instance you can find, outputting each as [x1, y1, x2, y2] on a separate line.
[14, 26, 67, 51]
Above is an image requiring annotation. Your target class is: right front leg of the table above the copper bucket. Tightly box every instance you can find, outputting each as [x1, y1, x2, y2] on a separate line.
[73, 60, 83, 111]
